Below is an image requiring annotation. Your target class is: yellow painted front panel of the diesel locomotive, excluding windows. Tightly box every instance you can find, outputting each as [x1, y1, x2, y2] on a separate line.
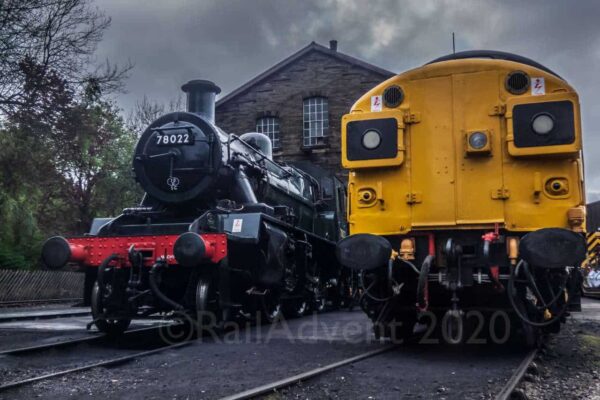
[342, 59, 584, 235]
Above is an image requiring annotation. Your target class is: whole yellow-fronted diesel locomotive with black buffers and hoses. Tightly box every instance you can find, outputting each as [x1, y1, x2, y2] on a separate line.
[337, 51, 585, 344]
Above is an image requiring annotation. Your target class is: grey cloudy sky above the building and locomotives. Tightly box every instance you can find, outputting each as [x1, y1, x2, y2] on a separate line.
[96, 0, 600, 200]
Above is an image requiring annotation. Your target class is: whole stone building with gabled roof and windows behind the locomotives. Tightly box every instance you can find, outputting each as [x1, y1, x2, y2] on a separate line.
[216, 40, 395, 178]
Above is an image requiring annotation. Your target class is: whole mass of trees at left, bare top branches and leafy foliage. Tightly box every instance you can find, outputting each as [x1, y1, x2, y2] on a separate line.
[0, 0, 140, 268]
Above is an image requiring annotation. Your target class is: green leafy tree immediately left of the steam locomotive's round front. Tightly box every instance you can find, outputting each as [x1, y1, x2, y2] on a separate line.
[55, 94, 139, 232]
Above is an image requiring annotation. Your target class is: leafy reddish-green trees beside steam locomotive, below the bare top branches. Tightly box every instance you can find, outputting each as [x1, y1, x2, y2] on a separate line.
[0, 64, 140, 267]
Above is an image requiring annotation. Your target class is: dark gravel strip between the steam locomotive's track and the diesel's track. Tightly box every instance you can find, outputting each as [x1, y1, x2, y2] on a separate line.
[0, 340, 384, 399]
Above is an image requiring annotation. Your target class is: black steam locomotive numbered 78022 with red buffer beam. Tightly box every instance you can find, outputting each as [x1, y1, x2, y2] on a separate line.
[42, 80, 351, 333]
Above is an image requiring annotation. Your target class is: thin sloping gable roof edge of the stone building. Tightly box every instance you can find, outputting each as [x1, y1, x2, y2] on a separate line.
[217, 42, 396, 107]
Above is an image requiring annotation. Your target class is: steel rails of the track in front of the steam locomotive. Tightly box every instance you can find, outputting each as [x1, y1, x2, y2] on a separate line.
[0, 325, 186, 393]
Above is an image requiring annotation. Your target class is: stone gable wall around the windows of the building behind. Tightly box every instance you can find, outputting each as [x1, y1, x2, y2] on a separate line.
[216, 51, 387, 179]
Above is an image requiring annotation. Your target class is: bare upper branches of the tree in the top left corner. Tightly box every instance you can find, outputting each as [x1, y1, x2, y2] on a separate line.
[0, 0, 131, 114]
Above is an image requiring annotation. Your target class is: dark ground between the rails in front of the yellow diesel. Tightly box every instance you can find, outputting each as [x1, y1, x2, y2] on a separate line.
[256, 346, 524, 400]
